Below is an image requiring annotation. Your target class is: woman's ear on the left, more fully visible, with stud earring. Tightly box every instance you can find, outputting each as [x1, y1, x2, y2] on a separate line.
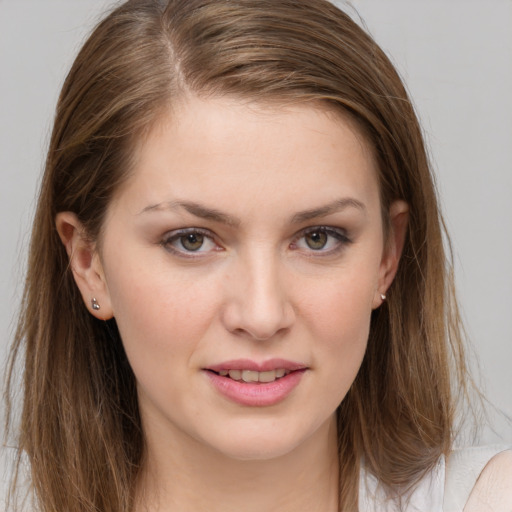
[55, 212, 114, 320]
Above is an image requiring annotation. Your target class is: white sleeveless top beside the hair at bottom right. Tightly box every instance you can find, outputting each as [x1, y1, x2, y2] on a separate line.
[359, 446, 512, 512]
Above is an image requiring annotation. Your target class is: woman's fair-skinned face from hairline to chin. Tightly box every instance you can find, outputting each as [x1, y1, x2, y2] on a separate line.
[85, 98, 401, 459]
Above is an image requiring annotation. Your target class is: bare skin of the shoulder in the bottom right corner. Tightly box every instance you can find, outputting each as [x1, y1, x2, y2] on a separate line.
[464, 449, 512, 512]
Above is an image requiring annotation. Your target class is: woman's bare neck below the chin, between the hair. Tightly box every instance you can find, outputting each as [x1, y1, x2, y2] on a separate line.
[136, 418, 338, 512]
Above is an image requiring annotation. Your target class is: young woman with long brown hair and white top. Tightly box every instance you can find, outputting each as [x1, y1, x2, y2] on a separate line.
[3, 0, 512, 512]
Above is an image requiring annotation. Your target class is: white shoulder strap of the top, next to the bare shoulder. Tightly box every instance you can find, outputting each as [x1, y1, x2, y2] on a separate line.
[443, 445, 511, 512]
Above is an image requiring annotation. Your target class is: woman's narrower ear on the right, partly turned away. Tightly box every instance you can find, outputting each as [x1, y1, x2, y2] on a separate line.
[373, 200, 409, 309]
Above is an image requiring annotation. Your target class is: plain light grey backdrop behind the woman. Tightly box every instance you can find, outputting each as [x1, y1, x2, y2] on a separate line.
[0, 0, 512, 470]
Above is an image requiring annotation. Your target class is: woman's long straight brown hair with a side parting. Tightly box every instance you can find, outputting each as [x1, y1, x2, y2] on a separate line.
[8, 0, 476, 512]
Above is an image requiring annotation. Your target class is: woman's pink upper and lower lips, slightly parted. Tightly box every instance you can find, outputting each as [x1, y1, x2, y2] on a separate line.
[203, 359, 308, 407]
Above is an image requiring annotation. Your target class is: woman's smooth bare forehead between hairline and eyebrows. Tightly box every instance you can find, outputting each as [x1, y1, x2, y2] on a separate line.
[116, 97, 378, 220]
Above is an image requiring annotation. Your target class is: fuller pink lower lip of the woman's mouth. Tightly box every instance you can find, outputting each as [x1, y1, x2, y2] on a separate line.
[206, 369, 306, 407]
